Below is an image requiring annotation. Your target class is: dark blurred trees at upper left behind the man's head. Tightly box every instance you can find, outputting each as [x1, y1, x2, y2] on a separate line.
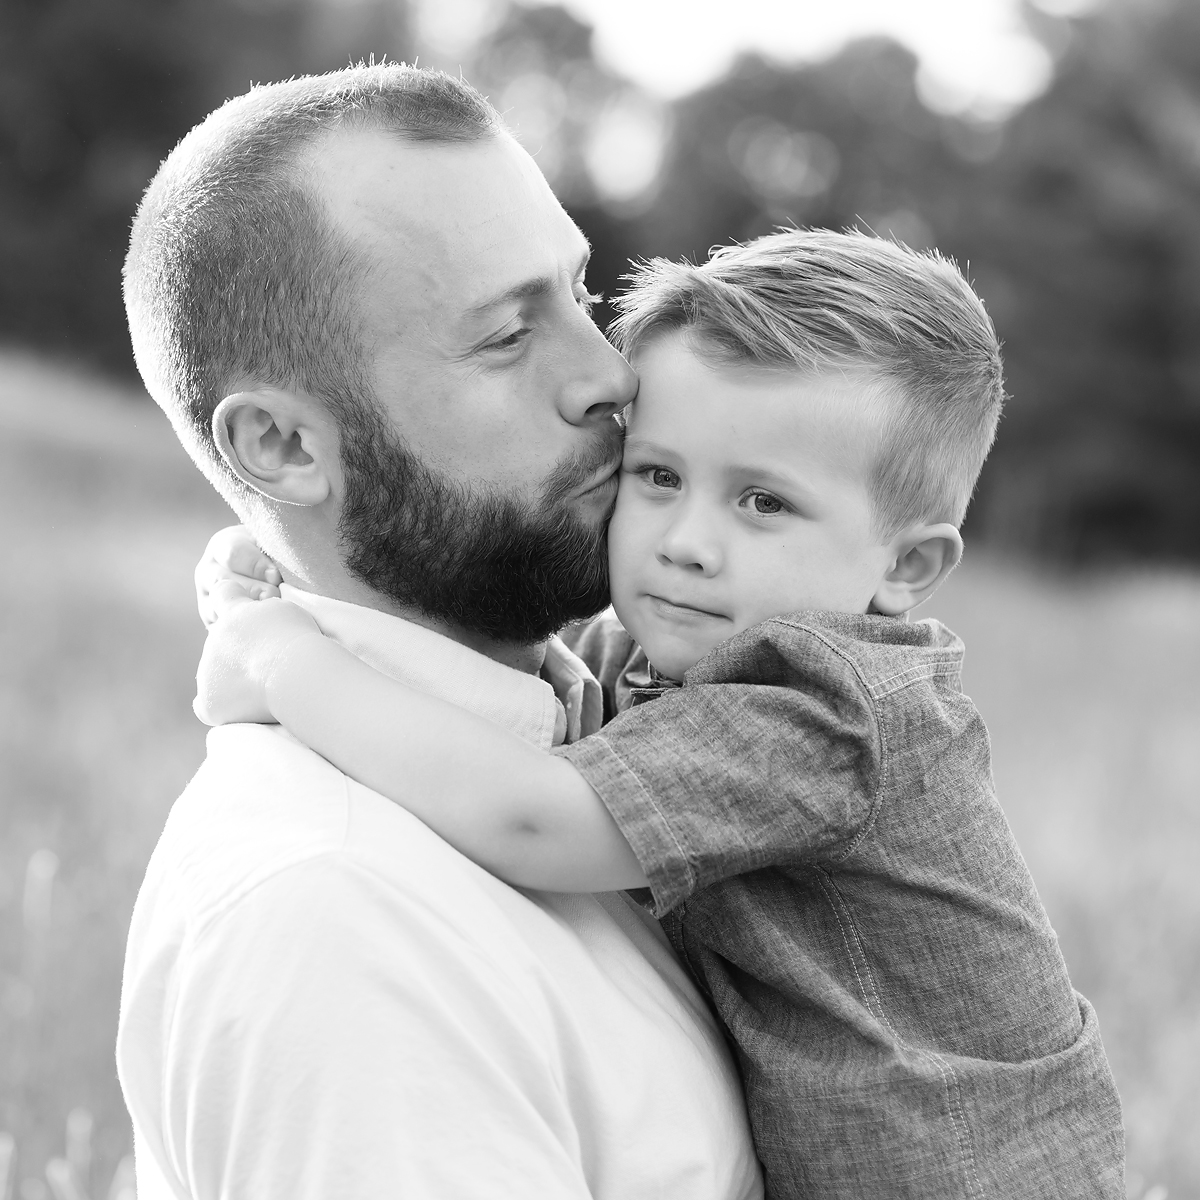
[0, 0, 408, 370]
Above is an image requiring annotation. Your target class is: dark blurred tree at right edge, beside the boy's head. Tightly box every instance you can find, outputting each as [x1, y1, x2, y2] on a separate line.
[955, 0, 1200, 560]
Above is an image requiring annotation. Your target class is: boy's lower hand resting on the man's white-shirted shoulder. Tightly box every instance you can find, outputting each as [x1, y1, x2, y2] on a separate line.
[199, 580, 322, 725]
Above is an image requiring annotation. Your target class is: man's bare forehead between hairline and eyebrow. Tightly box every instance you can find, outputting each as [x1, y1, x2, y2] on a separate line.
[297, 128, 587, 307]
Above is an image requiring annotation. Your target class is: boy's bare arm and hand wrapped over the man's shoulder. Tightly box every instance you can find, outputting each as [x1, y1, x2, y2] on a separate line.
[197, 595, 646, 892]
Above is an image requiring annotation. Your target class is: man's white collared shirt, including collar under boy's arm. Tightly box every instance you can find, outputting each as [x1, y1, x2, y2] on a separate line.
[118, 593, 762, 1200]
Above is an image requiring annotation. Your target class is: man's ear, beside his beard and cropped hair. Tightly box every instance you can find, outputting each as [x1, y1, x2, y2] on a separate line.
[212, 388, 337, 506]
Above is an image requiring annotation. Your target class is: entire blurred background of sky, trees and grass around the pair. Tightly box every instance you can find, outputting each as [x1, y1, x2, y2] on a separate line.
[0, 0, 1200, 1200]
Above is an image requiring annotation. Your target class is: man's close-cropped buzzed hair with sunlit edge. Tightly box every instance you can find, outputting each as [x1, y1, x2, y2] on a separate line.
[125, 64, 503, 508]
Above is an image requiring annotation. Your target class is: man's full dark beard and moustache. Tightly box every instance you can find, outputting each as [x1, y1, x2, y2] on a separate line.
[338, 414, 619, 646]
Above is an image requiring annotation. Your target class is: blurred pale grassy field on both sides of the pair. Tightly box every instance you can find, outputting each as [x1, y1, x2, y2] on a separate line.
[0, 355, 1200, 1200]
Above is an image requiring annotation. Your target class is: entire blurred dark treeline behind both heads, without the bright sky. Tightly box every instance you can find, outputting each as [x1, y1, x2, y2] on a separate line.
[0, 0, 1200, 559]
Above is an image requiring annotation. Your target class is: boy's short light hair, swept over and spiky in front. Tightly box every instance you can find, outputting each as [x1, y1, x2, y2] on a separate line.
[610, 229, 1004, 538]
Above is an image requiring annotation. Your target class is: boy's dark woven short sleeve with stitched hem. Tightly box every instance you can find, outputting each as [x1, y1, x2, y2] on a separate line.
[559, 622, 881, 916]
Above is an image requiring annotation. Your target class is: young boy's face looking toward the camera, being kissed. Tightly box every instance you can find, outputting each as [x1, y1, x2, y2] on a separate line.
[608, 330, 895, 679]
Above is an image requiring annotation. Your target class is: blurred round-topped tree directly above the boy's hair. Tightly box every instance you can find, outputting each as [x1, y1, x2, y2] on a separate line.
[640, 38, 971, 268]
